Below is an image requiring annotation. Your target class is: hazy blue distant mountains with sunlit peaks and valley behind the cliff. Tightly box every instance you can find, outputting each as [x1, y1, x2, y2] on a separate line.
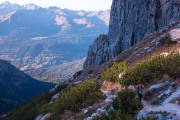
[0, 2, 110, 82]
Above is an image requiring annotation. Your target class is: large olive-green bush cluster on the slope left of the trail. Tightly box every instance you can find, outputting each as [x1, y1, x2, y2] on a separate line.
[52, 79, 103, 117]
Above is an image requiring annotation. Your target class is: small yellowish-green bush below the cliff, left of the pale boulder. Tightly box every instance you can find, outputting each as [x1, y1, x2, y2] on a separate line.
[101, 62, 127, 82]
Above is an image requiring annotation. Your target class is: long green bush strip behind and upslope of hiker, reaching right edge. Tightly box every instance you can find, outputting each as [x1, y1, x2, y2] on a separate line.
[120, 54, 180, 85]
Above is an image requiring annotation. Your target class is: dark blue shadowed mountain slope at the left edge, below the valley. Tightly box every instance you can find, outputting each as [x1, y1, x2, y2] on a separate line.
[0, 59, 55, 115]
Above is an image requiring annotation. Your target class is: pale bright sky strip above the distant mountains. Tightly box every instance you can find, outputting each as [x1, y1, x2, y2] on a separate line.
[0, 0, 112, 10]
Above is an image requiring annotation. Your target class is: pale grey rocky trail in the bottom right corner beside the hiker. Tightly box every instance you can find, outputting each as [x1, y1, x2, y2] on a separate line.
[137, 83, 180, 120]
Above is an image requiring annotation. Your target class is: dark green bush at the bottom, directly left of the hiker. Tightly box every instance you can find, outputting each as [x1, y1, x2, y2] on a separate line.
[94, 89, 142, 120]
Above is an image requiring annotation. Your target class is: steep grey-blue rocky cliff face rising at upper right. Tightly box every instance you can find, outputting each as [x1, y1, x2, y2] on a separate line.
[84, 0, 180, 69]
